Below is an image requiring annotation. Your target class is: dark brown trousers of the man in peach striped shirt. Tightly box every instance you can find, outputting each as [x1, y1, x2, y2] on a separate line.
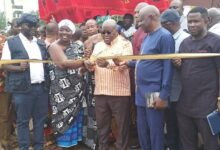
[95, 96, 131, 150]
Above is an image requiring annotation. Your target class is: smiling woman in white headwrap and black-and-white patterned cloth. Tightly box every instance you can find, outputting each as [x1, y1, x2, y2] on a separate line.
[49, 19, 85, 148]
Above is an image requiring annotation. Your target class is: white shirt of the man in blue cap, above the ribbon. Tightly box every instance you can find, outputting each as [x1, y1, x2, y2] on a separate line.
[173, 28, 189, 53]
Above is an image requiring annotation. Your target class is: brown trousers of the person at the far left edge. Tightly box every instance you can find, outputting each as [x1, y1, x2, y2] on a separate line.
[0, 92, 12, 145]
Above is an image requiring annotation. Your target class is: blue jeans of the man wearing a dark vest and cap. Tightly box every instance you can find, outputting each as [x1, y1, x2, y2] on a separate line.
[13, 84, 48, 150]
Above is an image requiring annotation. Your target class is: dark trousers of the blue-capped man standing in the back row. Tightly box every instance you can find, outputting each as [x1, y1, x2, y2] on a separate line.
[165, 102, 181, 150]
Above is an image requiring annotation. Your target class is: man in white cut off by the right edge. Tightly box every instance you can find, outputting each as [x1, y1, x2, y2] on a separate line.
[208, 8, 220, 35]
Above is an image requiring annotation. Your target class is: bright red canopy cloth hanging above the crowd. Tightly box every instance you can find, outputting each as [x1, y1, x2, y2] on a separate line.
[38, 0, 169, 23]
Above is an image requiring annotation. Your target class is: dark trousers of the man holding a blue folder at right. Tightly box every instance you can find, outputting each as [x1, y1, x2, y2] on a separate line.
[177, 113, 219, 150]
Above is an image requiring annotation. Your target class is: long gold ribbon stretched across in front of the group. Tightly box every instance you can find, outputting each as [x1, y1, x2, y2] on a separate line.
[0, 53, 220, 65]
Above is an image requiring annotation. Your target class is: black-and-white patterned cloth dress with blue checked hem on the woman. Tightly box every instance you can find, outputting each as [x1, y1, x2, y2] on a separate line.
[49, 43, 85, 147]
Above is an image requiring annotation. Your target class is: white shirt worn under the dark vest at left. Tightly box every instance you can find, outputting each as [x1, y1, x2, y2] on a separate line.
[1, 33, 44, 84]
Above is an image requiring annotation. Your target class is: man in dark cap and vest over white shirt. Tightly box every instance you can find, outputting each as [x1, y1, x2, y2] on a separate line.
[1, 14, 48, 150]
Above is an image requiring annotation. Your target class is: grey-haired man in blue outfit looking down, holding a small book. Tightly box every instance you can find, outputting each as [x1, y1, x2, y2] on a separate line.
[136, 5, 175, 150]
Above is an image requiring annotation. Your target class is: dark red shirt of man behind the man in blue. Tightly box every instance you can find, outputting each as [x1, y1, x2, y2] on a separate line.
[132, 27, 147, 55]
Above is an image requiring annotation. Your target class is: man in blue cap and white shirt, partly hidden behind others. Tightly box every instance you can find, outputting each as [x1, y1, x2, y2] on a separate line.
[160, 9, 189, 150]
